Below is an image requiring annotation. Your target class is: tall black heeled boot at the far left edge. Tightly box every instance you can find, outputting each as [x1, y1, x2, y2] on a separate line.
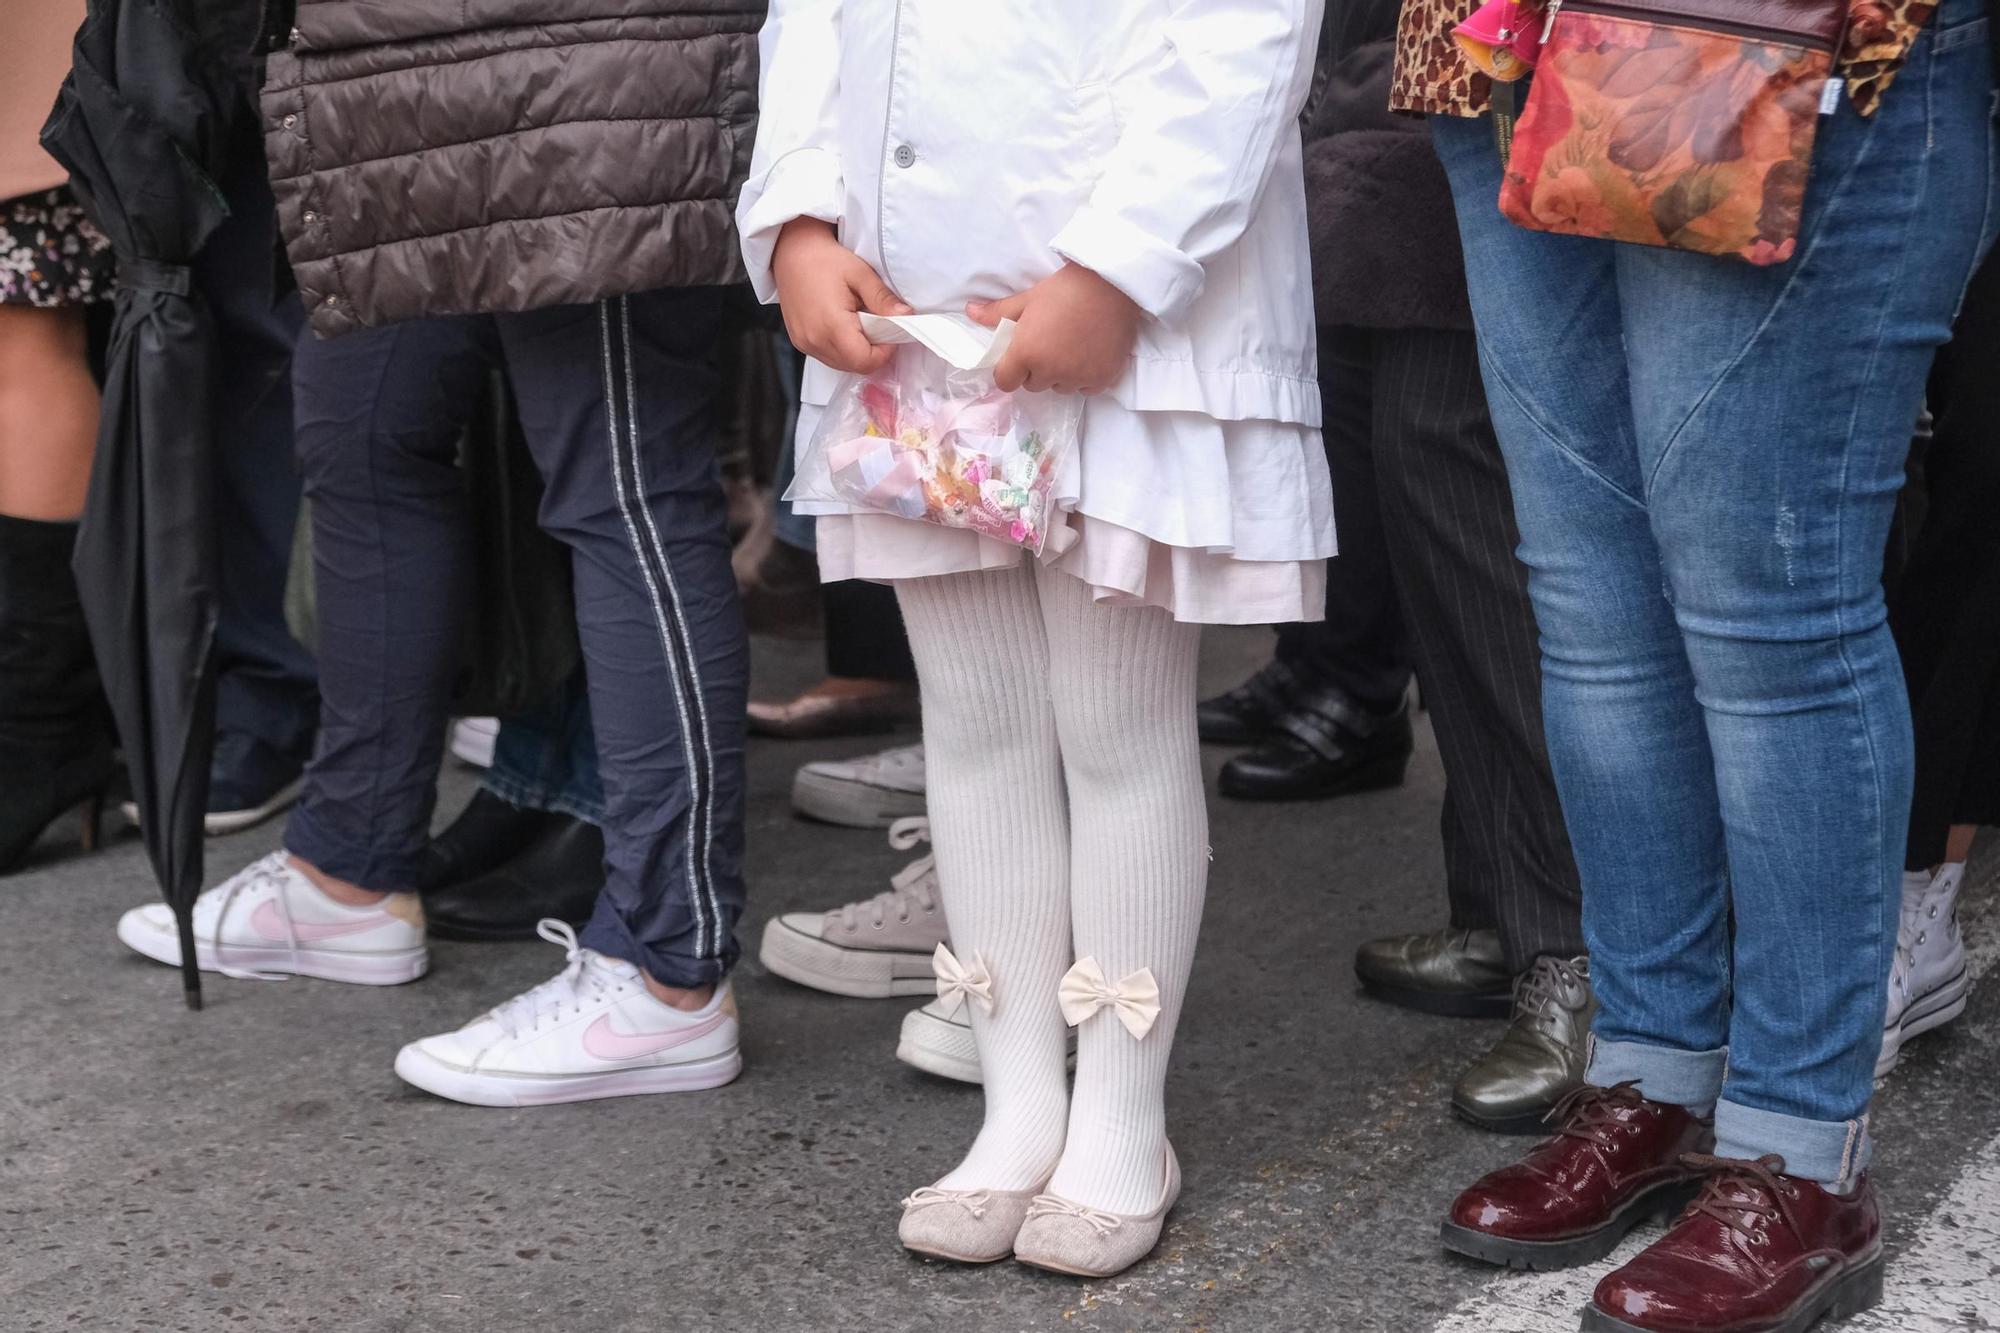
[0, 514, 116, 875]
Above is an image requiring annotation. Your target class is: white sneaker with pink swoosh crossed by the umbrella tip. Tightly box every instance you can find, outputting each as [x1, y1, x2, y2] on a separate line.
[118, 851, 430, 987]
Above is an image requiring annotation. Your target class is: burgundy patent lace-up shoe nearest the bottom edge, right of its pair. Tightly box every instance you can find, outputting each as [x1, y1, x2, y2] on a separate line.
[1584, 1157, 1882, 1333]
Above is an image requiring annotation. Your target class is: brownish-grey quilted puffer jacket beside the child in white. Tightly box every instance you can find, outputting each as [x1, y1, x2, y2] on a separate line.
[264, 0, 766, 336]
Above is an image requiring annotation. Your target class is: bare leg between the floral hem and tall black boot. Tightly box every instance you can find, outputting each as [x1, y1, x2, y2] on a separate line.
[0, 306, 98, 522]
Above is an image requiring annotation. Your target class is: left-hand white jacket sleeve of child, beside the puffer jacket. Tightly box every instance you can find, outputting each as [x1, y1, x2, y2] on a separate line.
[736, 0, 846, 302]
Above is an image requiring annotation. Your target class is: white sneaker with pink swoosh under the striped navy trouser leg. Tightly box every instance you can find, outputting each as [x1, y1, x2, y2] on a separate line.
[396, 921, 744, 1107]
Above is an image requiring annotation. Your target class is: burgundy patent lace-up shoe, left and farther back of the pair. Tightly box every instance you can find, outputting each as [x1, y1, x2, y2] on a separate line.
[1440, 1083, 1714, 1269]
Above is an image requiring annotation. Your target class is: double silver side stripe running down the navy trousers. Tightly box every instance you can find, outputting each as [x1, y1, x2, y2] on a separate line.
[598, 296, 722, 959]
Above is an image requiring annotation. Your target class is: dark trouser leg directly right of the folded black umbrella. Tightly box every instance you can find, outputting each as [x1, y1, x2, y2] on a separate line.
[194, 134, 318, 759]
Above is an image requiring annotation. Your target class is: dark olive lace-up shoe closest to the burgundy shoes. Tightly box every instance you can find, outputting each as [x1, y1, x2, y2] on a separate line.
[1452, 959, 1598, 1135]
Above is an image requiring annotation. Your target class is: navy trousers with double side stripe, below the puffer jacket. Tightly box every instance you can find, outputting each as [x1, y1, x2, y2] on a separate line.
[286, 290, 750, 987]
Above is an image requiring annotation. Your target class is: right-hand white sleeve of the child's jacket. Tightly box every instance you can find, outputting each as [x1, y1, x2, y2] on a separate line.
[1052, 0, 1322, 324]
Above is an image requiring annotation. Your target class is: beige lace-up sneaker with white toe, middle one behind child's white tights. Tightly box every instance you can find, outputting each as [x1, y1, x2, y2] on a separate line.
[758, 819, 944, 999]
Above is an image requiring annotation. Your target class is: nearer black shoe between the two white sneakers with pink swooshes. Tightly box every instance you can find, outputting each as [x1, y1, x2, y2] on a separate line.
[424, 815, 604, 941]
